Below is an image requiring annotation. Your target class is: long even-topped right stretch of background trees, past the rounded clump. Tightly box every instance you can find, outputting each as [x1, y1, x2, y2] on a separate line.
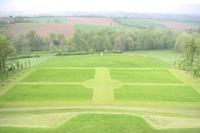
[68, 29, 176, 52]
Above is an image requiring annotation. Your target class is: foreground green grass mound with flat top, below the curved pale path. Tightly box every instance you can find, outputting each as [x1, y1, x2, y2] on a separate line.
[0, 114, 200, 133]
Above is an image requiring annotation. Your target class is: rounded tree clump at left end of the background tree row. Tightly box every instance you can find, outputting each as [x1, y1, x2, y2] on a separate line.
[13, 31, 67, 53]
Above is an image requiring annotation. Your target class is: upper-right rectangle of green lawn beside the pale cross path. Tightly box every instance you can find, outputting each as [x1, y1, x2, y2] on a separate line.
[110, 69, 181, 83]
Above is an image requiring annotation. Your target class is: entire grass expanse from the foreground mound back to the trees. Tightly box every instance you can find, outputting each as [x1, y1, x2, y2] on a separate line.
[0, 51, 200, 133]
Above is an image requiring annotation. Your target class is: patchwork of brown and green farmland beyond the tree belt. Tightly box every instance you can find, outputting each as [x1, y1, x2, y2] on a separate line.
[1, 16, 198, 38]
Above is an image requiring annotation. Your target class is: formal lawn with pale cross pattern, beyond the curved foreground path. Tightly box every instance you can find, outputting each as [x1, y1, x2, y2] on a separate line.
[0, 54, 200, 106]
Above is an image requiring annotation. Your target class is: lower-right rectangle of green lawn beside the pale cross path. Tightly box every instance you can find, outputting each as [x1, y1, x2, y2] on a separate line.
[114, 85, 200, 102]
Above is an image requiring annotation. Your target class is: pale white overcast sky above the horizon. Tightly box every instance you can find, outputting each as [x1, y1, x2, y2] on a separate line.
[0, 0, 200, 14]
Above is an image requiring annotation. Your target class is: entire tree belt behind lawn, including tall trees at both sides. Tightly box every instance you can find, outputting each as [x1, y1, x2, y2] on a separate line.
[0, 28, 200, 77]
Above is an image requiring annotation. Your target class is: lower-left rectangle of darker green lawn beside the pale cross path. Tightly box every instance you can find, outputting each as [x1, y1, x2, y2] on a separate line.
[0, 85, 93, 102]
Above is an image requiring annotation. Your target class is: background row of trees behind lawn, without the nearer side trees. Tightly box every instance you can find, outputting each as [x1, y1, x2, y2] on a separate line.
[14, 29, 176, 53]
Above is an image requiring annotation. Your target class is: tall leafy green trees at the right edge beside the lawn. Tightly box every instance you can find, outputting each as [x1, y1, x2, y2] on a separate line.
[175, 32, 200, 78]
